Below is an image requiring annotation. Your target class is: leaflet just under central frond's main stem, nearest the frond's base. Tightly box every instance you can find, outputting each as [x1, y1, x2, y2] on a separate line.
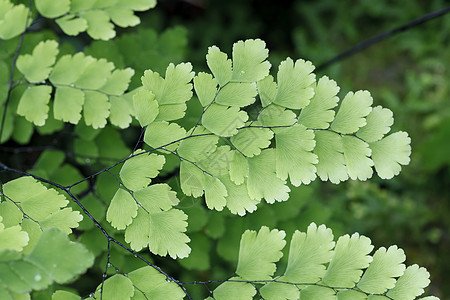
[177, 126, 219, 161]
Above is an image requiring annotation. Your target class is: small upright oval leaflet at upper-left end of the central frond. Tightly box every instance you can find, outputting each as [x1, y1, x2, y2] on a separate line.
[133, 90, 159, 127]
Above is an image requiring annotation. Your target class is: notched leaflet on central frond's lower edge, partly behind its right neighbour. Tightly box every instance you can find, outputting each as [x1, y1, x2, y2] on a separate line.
[247, 149, 290, 203]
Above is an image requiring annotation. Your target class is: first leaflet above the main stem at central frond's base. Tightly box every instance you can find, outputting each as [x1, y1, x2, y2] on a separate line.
[144, 121, 186, 151]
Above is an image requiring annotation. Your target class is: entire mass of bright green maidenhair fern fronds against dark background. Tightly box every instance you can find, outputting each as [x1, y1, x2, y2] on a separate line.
[0, 0, 436, 300]
